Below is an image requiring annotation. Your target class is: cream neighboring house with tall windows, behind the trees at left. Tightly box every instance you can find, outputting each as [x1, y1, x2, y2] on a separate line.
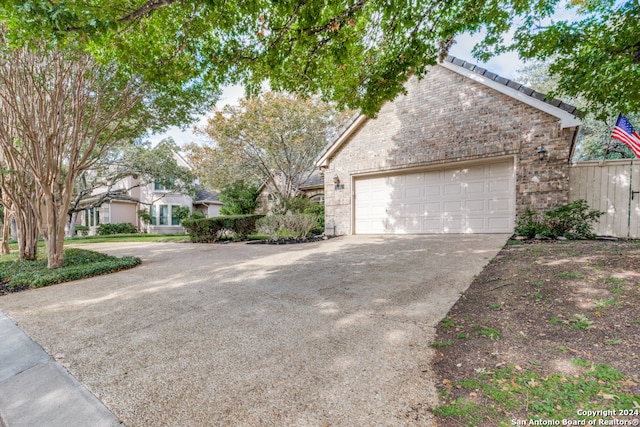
[78, 148, 222, 234]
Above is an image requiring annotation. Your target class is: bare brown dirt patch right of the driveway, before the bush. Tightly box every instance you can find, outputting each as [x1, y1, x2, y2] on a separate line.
[434, 241, 640, 425]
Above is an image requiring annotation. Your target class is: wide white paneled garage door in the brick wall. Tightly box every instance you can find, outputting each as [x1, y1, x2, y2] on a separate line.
[355, 159, 515, 234]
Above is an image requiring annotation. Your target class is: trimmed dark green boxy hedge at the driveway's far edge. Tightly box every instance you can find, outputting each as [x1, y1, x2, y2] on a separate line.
[182, 215, 264, 243]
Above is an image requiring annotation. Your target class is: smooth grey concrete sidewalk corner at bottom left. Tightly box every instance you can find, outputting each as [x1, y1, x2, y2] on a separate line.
[0, 312, 122, 427]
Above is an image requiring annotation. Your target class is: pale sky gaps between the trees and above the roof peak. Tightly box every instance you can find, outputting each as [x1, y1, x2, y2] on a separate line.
[147, 35, 524, 146]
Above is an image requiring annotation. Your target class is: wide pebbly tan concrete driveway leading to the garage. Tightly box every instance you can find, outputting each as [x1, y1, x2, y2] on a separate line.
[0, 235, 508, 427]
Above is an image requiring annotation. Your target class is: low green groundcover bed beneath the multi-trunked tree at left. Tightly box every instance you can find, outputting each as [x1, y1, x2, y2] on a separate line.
[0, 248, 140, 291]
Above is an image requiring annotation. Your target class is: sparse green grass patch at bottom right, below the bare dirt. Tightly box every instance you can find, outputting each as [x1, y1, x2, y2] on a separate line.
[433, 359, 640, 426]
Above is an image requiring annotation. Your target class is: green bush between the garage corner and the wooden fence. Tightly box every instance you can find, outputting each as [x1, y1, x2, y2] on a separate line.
[515, 200, 604, 239]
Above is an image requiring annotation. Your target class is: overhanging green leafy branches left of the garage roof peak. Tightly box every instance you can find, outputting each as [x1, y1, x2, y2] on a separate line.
[0, 0, 533, 116]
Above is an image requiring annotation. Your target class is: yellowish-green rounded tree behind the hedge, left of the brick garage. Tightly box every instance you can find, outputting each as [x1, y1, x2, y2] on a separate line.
[187, 93, 348, 214]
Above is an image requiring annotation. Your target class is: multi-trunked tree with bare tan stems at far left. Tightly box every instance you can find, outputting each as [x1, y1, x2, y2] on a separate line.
[0, 39, 152, 268]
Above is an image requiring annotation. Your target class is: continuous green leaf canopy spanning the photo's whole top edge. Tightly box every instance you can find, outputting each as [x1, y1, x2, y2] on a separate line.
[0, 0, 640, 120]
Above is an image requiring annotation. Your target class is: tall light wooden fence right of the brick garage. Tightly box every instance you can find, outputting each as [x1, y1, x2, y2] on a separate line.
[569, 159, 640, 239]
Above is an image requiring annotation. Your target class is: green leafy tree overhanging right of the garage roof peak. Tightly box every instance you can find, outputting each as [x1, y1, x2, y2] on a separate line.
[475, 0, 640, 121]
